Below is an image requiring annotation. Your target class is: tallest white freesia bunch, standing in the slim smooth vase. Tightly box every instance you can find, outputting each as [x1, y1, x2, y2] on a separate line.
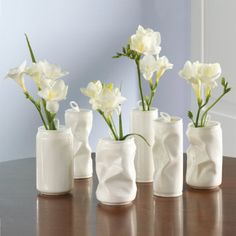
[113, 25, 173, 111]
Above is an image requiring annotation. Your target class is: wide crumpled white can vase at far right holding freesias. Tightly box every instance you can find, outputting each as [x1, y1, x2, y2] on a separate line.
[186, 121, 223, 189]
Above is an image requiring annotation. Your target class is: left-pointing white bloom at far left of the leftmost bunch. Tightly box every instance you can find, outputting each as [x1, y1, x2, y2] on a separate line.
[5, 61, 27, 92]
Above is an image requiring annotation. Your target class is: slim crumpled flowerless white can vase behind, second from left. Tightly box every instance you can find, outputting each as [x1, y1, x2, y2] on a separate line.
[65, 109, 93, 179]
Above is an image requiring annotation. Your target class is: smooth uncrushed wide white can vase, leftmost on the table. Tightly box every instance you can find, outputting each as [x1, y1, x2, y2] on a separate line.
[36, 126, 73, 195]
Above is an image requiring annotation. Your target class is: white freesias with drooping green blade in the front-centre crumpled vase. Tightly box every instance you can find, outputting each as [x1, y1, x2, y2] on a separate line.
[81, 80, 149, 145]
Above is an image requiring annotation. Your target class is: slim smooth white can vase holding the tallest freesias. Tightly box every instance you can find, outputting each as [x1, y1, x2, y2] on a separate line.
[130, 108, 158, 183]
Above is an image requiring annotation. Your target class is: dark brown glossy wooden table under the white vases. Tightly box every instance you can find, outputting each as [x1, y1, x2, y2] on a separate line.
[0, 158, 236, 236]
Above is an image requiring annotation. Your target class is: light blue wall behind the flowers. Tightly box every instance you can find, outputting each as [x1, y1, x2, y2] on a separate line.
[0, 0, 190, 161]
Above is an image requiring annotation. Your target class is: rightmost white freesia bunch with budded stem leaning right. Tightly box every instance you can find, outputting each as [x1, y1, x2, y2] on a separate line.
[179, 61, 231, 128]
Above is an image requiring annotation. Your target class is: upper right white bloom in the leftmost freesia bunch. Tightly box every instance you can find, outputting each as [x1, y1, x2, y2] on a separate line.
[38, 61, 68, 80]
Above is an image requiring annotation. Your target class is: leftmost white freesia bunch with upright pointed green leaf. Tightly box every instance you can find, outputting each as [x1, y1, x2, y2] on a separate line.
[6, 34, 68, 130]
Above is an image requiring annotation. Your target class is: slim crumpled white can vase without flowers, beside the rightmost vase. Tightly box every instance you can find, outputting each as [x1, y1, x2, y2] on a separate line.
[153, 117, 183, 197]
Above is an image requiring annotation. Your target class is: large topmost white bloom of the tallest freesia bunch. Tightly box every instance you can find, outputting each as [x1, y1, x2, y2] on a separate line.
[130, 25, 161, 55]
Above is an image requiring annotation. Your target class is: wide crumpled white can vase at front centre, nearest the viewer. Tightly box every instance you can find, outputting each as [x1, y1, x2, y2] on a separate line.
[96, 138, 137, 205]
